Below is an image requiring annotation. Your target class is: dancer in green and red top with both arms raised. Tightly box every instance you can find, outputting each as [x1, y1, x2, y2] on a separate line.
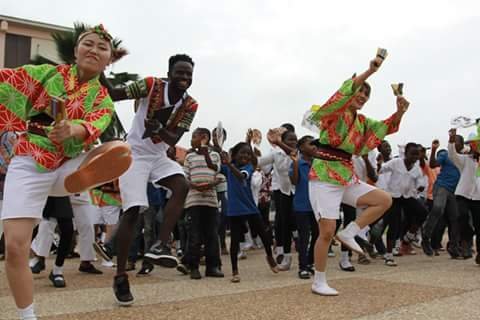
[306, 52, 409, 295]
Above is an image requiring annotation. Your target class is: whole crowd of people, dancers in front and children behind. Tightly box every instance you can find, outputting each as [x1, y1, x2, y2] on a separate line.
[0, 25, 480, 319]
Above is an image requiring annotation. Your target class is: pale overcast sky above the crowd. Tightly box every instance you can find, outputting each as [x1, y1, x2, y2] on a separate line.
[0, 0, 480, 154]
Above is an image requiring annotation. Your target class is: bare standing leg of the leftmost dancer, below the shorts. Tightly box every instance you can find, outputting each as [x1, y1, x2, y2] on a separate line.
[3, 218, 35, 309]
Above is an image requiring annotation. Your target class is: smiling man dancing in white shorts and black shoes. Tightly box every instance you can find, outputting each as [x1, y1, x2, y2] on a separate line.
[102, 54, 198, 305]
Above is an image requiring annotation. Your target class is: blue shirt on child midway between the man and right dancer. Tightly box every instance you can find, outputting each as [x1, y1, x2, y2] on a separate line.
[222, 164, 260, 217]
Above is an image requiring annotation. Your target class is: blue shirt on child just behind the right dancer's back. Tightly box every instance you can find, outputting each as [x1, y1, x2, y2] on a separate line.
[288, 158, 313, 213]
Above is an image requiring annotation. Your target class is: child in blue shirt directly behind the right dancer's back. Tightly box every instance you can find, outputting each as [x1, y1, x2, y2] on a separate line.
[289, 136, 318, 279]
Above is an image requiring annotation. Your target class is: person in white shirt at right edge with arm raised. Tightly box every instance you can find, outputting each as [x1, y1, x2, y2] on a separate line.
[448, 129, 480, 264]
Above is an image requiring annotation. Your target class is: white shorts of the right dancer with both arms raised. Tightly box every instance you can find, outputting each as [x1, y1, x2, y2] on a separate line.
[308, 180, 377, 220]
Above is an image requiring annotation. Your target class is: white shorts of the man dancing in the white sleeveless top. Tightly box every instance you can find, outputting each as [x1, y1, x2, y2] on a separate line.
[119, 153, 185, 211]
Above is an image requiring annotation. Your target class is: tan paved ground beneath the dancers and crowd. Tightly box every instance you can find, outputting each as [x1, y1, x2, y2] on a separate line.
[0, 250, 480, 320]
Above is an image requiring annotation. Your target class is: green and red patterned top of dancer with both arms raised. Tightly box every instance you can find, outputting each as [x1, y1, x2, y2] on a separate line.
[306, 79, 398, 185]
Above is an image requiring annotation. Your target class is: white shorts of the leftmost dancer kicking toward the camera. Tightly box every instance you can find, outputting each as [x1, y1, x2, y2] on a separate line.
[1, 152, 88, 220]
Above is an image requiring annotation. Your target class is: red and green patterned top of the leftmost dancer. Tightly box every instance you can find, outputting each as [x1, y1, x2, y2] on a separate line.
[0, 64, 113, 171]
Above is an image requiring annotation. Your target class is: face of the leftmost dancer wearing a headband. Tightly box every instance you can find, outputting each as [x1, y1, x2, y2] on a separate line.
[75, 32, 112, 77]
